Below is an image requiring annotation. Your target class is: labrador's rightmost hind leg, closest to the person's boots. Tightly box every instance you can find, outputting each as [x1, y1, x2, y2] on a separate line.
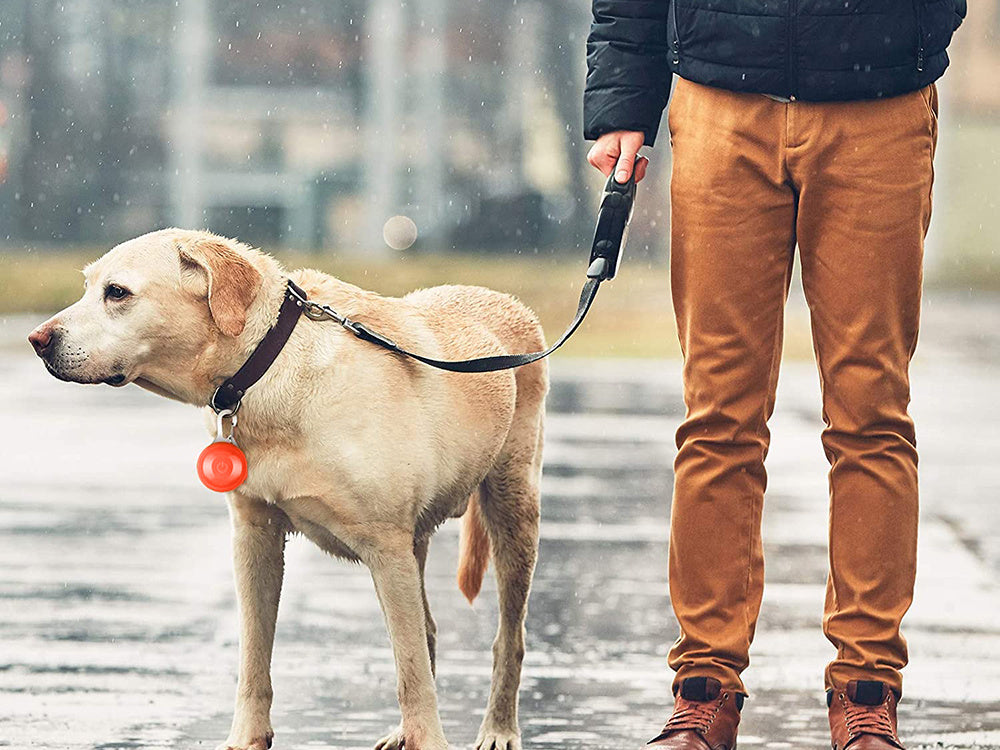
[476, 415, 542, 750]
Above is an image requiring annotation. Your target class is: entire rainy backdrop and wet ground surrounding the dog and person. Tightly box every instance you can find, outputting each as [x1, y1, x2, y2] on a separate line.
[0, 0, 1000, 750]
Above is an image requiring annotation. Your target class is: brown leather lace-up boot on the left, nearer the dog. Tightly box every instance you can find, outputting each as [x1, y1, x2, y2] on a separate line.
[647, 677, 743, 750]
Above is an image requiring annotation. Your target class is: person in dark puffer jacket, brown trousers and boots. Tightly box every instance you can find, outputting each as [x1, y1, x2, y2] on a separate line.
[584, 0, 966, 750]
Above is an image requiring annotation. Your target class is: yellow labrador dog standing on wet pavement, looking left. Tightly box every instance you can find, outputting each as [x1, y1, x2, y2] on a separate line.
[30, 229, 548, 750]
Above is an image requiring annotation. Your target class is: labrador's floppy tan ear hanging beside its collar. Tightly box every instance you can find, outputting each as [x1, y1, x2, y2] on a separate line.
[178, 238, 262, 336]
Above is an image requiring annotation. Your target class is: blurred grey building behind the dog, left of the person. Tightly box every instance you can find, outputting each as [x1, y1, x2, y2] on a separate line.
[0, 0, 591, 249]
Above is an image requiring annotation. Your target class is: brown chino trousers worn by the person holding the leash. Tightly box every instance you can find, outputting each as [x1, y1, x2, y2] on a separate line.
[669, 79, 937, 692]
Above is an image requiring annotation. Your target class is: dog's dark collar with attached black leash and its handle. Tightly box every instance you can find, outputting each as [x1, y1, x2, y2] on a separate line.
[209, 164, 635, 413]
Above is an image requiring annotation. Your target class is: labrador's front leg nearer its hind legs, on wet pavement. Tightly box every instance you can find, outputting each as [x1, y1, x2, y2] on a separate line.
[365, 535, 448, 750]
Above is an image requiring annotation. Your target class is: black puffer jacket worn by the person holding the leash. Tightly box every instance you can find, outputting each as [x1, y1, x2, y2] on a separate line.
[583, 0, 966, 145]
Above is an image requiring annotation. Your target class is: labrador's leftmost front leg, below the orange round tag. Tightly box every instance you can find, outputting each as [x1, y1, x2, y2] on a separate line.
[219, 493, 290, 750]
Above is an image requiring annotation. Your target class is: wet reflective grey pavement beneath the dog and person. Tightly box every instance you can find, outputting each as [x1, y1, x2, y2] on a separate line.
[0, 298, 1000, 750]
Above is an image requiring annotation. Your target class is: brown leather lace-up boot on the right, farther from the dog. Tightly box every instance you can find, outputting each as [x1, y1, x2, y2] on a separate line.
[826, 680, 903, 750]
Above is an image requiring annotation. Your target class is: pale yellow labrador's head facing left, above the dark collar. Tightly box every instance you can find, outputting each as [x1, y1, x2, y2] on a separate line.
[28, 229, 266, 400]
